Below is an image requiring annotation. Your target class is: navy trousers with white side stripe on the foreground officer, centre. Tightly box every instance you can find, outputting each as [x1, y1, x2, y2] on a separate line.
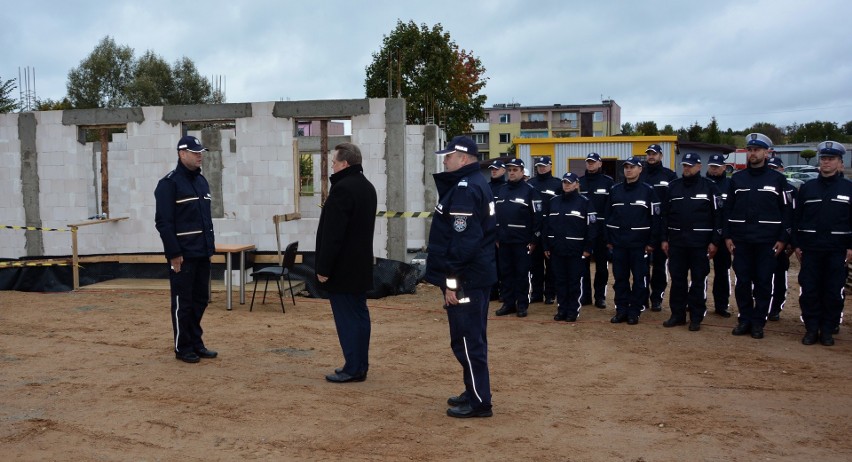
[444, 288, 492, 410]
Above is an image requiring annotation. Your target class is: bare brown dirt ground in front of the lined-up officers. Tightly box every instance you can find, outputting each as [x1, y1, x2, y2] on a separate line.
[0, 262, 852, 462]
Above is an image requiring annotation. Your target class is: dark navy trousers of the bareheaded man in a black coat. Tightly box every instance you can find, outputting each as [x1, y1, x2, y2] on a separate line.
[328, 292, 370, 375]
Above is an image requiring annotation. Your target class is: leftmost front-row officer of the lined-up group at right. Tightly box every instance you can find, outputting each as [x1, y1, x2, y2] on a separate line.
[495, 159, 542, 318]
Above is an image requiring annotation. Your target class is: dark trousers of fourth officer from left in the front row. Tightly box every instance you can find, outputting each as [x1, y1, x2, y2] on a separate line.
[669, 246, 710, 323]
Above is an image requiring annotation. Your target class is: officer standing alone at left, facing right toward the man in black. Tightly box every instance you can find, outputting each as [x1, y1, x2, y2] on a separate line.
[154, 136, 217, 363]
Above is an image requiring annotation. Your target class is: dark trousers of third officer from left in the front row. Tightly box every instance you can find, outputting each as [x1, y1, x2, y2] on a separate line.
[612, 247, 650, 316]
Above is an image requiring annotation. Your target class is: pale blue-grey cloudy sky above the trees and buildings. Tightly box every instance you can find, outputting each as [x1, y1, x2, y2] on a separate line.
[0, 0, 852, 130]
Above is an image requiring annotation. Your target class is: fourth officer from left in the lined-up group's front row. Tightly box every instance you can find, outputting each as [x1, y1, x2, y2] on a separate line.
[661, 152, 722, 331]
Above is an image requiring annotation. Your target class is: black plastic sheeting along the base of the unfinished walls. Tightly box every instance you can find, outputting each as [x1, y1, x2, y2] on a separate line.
[0, 252, 423, 299]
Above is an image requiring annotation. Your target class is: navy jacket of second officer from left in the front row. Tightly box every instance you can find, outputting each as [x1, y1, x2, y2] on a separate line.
[542, 191, 598, 256]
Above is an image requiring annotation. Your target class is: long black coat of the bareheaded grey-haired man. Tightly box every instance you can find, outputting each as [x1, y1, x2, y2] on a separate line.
[315, 165, 377, 294]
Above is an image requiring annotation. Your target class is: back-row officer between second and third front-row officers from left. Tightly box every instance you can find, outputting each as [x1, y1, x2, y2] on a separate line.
[576, 152, 615, 308]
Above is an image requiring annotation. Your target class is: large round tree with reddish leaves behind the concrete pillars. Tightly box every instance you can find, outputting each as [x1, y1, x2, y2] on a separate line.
[364, 20, 487, 137]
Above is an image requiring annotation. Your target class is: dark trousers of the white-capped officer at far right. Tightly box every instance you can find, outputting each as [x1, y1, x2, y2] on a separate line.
[799, 250, 847, 332]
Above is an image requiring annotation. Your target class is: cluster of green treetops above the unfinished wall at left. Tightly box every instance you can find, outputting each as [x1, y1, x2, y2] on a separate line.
[67, 36, 225, 109]
